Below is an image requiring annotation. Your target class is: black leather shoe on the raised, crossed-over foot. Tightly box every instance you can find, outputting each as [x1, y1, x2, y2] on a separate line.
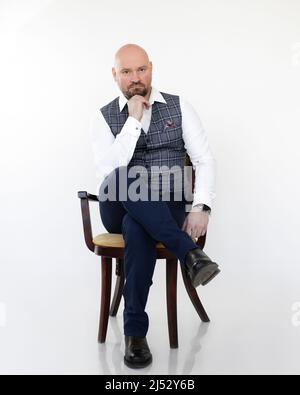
[185, 248, 220, 288]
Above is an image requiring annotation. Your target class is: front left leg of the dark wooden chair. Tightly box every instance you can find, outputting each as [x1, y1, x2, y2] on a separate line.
[98, 256, 112, 343]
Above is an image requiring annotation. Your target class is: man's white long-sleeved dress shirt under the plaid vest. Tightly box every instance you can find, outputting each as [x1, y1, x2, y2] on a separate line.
[90, 87, 216, 208]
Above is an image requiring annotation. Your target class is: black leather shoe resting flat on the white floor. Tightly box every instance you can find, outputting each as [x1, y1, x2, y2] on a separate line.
[124, 336, 152, 369]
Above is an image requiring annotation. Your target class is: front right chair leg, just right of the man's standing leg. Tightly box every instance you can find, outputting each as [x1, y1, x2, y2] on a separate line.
[166, 259, 178, 348]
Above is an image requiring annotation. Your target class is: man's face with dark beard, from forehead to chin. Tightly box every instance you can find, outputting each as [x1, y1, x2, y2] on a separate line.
[112, 54, 152, 100]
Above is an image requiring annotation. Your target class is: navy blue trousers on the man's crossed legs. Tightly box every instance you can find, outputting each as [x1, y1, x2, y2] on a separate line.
[99, 167, 198, 337]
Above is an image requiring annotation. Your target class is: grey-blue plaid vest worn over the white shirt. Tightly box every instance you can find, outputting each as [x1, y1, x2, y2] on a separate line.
[101, 92, 186, 196]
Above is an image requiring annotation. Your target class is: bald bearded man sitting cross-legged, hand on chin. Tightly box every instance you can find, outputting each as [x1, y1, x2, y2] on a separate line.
[91, 44, 220, 368]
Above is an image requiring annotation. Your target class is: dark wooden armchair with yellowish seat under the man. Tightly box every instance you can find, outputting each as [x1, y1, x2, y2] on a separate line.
[78, 156, 209, 348]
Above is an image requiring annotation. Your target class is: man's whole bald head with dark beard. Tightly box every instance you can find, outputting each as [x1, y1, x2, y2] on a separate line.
[112, 44, 152, 99]
